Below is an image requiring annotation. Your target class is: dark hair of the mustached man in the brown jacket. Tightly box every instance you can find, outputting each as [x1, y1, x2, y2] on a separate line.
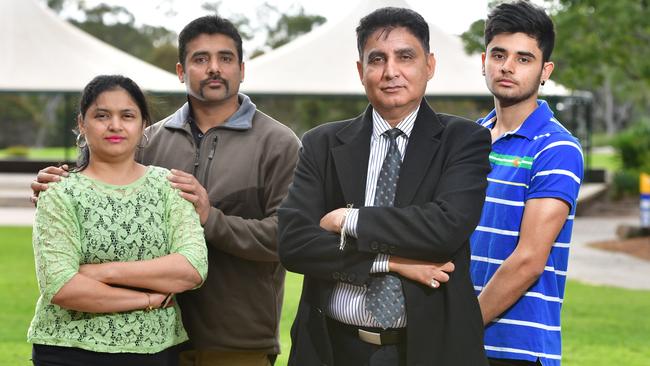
[178, 15, 244, 67]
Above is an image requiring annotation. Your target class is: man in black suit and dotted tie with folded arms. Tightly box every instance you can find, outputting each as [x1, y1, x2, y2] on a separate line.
[278, 8, 490, 366]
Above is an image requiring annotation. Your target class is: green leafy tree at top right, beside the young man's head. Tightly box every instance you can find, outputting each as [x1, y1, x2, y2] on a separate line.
[554, 0, 650, 135]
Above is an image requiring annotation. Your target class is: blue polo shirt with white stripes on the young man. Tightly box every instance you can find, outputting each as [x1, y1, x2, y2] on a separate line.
[470, 101, 583, 365]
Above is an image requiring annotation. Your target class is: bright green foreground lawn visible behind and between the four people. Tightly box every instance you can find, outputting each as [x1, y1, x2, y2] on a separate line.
[0, 227, 650, 366]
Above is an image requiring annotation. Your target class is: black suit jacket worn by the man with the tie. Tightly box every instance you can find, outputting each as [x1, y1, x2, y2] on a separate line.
[278, 100, 491, 366]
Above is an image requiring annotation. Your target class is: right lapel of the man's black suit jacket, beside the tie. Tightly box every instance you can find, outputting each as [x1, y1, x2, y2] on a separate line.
[395, 98, 443, 207]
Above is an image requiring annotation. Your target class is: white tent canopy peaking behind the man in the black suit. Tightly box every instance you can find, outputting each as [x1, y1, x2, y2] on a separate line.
[241, 0, 570, 96]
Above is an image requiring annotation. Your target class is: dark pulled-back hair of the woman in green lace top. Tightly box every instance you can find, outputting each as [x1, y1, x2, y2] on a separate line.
[74, 75, 151, 172]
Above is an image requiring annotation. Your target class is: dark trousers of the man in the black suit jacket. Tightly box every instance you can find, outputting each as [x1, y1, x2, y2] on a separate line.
[327, 319, 406, 366]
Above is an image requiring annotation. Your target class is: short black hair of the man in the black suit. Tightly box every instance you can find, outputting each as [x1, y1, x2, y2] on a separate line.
[357, 7, 429, 60]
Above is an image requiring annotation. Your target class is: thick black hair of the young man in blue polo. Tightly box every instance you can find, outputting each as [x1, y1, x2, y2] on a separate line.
[485, 0, 555, 62]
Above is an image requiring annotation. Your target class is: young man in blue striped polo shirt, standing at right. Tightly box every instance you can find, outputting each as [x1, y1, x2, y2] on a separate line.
[471, 1, 583, 366]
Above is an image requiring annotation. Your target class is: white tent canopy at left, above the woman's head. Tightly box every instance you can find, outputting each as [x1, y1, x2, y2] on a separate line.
[0, 0, 185, 93]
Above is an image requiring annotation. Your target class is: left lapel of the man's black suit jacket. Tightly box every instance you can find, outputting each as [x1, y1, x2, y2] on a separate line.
[332, 107, 372, 207]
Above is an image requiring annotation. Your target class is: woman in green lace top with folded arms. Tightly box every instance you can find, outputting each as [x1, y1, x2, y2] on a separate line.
[28, 76, 207, 366]
